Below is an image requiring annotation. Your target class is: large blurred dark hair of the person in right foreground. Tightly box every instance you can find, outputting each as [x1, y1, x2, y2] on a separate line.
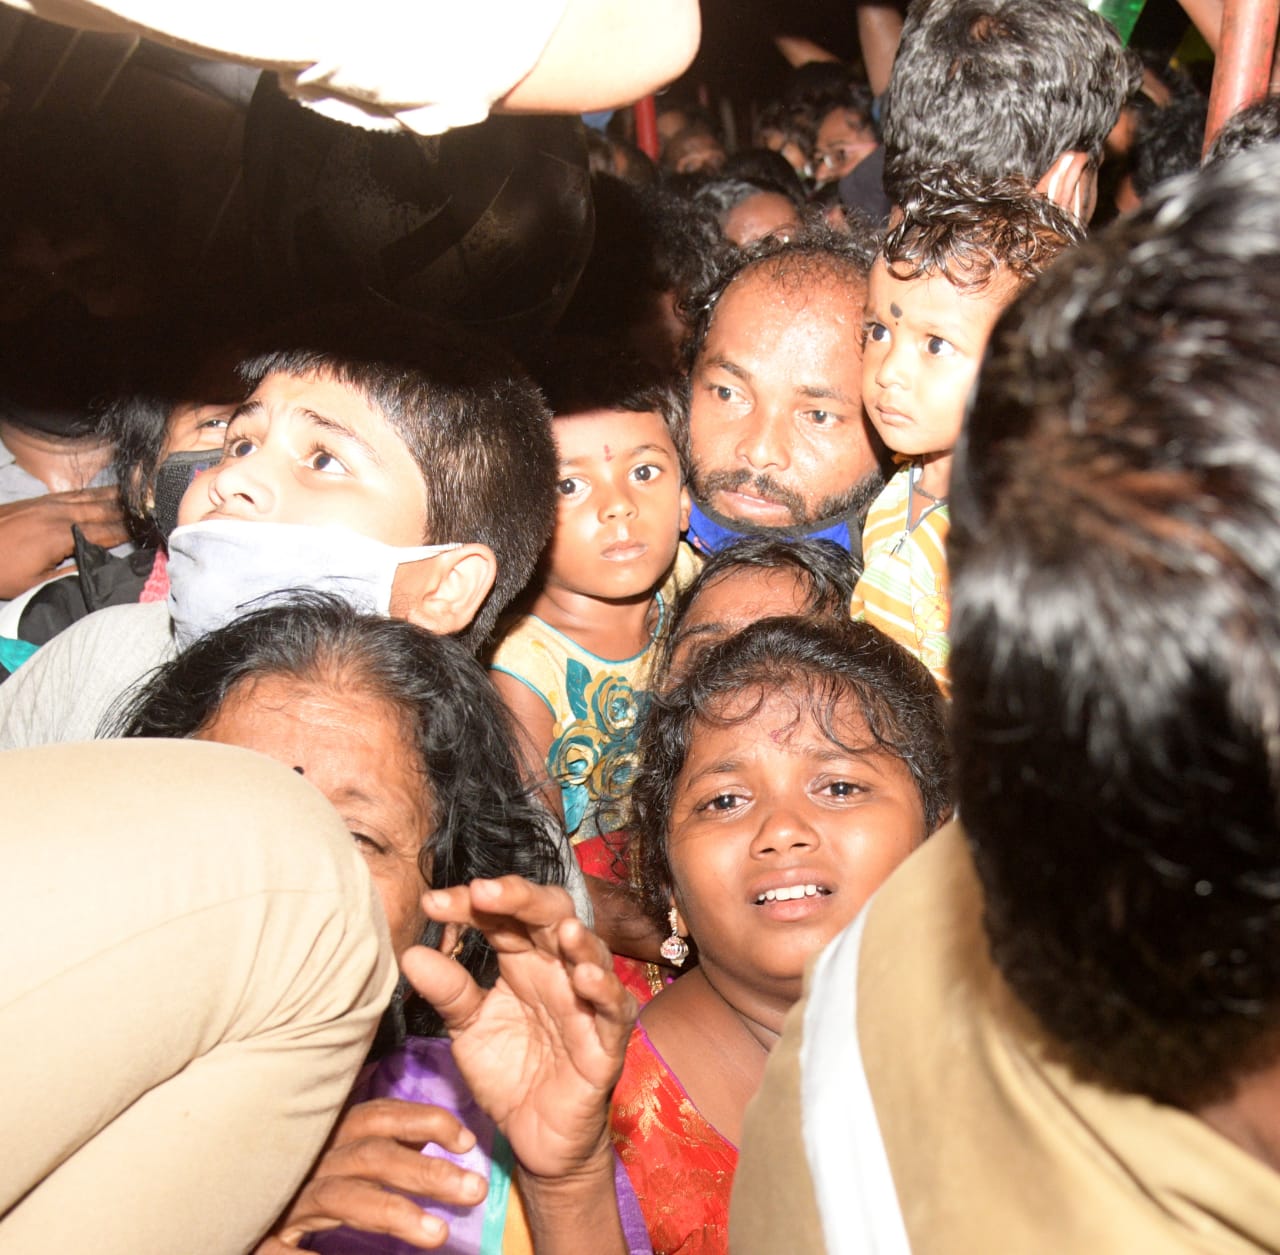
[947, 147, 1280, 1108]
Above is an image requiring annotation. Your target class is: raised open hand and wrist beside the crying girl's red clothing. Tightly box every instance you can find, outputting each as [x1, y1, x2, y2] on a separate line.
[402, 876, 636, 1255]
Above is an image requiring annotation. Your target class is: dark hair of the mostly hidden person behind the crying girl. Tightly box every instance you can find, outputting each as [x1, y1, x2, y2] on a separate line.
[653, 537, 861, 688]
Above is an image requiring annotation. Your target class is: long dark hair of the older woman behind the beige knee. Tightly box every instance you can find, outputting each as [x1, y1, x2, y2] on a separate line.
[104, 594, 563, 1032]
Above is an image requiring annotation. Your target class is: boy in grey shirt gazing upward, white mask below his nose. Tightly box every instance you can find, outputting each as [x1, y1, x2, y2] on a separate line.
[0, 307, 556, 748]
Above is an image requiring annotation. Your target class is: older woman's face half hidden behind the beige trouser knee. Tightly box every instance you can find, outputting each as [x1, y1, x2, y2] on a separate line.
[196, 675, 430, 954]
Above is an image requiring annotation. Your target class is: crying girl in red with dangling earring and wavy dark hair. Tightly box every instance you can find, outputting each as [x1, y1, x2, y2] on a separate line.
[612, 619, 948, 1252]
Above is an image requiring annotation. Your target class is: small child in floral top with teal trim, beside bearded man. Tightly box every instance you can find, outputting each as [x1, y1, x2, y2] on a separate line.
[490, 350, 696, 841]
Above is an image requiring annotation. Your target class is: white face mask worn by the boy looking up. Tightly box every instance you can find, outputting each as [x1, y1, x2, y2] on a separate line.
[169, 519, 458, 649]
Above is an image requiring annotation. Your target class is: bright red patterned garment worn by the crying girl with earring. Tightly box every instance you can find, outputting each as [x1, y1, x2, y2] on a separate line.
[611, 1024, 737, 1255]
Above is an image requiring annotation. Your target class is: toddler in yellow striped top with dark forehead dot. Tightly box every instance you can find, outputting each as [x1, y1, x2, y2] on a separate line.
[852, 174, 1083, 688]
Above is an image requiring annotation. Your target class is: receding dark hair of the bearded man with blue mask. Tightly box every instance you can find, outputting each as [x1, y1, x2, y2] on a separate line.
[684, 219, 879, 371]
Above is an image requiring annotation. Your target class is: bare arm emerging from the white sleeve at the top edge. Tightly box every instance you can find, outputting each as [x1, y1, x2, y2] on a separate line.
[498, 0, 701, 113]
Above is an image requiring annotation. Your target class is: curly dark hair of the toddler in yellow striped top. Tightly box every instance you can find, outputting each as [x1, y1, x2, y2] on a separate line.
[881, 169, 1084, 292]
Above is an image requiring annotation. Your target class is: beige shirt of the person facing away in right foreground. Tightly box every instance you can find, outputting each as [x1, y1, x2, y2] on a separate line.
[730, 825, 1280, 1255]
